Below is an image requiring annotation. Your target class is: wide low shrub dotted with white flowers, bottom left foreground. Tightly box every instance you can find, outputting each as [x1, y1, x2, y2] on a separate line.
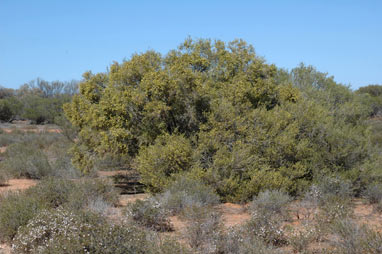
[12, 207, 157, 254]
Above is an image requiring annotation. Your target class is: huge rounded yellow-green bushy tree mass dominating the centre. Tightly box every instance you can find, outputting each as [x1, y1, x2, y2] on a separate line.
[64, 39, 380, 201]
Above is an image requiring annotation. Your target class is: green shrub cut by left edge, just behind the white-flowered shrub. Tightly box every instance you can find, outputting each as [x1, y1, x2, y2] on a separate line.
[0, 193, 47, 242]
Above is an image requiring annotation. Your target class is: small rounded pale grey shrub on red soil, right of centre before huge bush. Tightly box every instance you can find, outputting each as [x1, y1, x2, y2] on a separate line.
[250, 190, 292, 216]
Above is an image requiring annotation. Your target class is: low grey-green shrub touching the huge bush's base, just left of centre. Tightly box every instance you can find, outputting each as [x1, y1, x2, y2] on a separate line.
[157, 176, 219, 214]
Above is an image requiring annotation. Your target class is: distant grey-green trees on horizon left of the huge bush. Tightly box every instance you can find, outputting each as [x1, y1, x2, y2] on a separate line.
[0, 78, 78, 124]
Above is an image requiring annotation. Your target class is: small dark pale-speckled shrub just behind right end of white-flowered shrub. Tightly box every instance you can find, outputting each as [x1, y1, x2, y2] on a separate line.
[126, 199, 173, 232]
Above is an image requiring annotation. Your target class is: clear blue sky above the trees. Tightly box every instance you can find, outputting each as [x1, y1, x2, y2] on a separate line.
[0, 0, 382, 89]
